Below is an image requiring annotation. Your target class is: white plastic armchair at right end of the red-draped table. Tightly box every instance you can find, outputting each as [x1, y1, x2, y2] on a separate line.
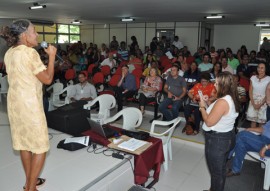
[150, 117, 181, 171]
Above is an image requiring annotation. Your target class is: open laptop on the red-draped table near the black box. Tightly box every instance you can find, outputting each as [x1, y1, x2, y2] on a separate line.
[87, 118, 118, 138]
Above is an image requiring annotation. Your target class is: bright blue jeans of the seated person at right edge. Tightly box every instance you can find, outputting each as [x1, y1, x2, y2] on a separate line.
[232, 131, 270, 173]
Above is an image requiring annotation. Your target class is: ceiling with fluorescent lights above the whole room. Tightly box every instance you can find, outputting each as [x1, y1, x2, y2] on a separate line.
[0, 0, 270, 24]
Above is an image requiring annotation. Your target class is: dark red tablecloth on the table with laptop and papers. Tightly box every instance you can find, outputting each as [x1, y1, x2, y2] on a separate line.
[83, 126, 164, 184]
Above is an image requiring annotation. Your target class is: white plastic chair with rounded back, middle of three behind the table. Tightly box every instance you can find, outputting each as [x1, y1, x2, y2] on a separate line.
[104, 107, 142, 131]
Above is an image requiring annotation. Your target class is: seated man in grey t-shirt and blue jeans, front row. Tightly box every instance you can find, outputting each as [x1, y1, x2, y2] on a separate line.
[159, 64, 187, 121]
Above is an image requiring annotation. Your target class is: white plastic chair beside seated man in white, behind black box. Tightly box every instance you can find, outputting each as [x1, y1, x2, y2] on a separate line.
[52, 85, 74, 107]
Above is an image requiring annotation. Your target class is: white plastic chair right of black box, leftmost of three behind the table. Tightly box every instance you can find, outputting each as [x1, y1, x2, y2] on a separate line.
[83, 94, 116, 124]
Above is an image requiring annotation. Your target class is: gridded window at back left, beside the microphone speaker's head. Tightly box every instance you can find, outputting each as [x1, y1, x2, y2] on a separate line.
[35, 24, 81, 44]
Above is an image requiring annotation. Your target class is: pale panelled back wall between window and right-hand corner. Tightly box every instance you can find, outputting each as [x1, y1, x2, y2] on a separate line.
[81, 22, 199, 53]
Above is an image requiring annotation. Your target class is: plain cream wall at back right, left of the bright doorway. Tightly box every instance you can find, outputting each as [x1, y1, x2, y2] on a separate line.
[213, 25, 260, 53]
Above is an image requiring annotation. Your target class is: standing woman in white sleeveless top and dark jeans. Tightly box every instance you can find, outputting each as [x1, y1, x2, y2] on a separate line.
[200, 72, 240, 191]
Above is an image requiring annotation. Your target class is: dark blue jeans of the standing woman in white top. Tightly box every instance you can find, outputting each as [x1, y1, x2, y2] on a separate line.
[205, 131, 235, 191]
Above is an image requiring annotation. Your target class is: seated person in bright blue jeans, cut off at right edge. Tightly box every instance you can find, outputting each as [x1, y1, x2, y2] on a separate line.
[227, 121, 270, 177]
